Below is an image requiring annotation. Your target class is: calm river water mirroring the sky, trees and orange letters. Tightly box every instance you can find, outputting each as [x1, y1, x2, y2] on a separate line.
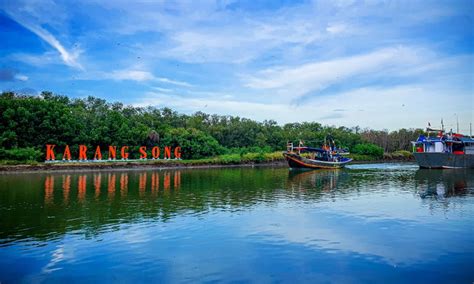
[0, 164, 474, 283]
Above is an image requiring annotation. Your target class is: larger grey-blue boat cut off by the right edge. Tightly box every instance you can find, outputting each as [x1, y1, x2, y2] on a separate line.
[412, 128, 474, 169]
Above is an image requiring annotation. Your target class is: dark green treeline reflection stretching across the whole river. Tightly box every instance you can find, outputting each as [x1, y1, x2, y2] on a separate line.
[0, 168, 474, 245]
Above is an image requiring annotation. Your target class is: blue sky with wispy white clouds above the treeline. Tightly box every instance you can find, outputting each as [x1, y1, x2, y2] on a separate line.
[0, 0, 474, 131]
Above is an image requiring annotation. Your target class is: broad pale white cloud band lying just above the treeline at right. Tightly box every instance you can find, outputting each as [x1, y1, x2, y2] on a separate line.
[135, 84, 474, 129]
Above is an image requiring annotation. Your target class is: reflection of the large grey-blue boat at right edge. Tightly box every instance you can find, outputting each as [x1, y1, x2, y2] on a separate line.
[415, 169, 474, 198]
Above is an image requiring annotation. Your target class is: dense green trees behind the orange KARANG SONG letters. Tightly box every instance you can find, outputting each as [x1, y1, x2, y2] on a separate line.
[0, 92, 418, 161]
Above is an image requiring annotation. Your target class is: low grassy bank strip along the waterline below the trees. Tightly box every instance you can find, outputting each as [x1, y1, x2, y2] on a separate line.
[0, 151, 413, 173]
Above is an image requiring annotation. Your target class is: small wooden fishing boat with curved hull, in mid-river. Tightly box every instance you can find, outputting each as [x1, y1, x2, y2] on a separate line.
[283, 141, 352, 169]
